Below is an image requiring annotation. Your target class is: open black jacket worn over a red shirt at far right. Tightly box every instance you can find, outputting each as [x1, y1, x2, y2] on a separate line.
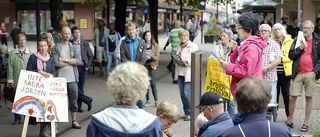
[289, 33, 320, 79]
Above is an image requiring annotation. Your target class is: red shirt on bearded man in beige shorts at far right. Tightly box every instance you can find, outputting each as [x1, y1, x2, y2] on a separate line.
[298, 39, 313, 74]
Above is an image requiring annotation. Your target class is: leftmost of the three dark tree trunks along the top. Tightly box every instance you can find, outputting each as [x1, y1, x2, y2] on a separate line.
[50, 0, 63, 31]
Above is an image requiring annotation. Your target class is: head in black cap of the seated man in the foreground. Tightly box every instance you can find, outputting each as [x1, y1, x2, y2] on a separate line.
[197, 92, 224, 120]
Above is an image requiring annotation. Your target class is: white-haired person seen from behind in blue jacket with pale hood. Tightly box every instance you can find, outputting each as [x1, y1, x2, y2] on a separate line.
[86, 62, 162, 137]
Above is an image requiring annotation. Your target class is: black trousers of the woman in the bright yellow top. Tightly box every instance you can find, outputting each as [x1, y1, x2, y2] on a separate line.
[277, 72, 291, 117]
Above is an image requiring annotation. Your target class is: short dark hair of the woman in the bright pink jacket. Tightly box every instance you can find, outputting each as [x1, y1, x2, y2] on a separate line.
[238, 13, 260, 35]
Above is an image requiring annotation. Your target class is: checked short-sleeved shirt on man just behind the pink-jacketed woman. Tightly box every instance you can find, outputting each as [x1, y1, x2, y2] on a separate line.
[262, 39, 282, 82]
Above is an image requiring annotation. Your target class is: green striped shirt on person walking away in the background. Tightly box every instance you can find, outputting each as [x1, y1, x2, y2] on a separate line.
[169, 26, 184, 54]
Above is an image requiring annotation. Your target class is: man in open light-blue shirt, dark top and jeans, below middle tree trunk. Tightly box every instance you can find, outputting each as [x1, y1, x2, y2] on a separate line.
[102, 23, 121, 79]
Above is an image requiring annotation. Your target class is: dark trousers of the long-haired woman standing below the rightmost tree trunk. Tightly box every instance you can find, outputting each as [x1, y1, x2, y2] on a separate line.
[146, 67, 158, 101]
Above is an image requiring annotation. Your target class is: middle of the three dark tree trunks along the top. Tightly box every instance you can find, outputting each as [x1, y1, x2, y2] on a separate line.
[114, 0, 128, 36]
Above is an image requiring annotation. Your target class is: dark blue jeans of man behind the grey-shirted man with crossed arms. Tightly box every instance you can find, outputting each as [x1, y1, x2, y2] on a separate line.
[77, 66, 91, 109]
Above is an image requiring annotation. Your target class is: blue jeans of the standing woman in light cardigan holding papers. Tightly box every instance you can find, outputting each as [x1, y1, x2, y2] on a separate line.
[178, 76, 191, 116]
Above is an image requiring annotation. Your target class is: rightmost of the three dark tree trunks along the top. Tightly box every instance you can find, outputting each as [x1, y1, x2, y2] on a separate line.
[148, 0, 158, 43]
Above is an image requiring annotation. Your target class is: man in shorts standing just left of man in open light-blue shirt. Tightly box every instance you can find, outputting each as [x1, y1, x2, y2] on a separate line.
[92, 19, 109, 77]
